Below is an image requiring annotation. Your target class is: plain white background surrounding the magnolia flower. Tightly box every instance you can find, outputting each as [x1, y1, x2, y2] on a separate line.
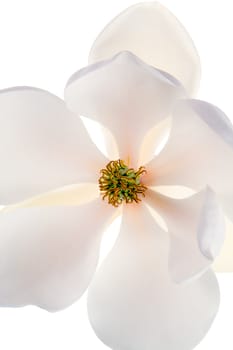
[0, 0, 233, 350]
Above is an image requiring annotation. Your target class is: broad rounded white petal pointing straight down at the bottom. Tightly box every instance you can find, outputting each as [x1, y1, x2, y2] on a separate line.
[88, 206, 219, 350]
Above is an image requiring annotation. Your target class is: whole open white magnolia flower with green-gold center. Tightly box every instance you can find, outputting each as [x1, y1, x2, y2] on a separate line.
[0, 3, 233, 350]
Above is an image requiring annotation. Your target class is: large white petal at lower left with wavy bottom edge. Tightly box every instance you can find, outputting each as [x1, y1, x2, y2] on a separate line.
[0, 199, 114, 311]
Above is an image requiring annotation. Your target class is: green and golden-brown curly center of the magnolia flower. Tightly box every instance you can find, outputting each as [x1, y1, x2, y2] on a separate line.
[99, 159, 147, 207]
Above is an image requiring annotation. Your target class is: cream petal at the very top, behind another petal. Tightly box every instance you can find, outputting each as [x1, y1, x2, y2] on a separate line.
[89, 2, 200, 94]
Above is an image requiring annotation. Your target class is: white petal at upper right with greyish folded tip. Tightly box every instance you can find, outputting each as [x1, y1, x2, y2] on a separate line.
[147, 100, 233, 200]
